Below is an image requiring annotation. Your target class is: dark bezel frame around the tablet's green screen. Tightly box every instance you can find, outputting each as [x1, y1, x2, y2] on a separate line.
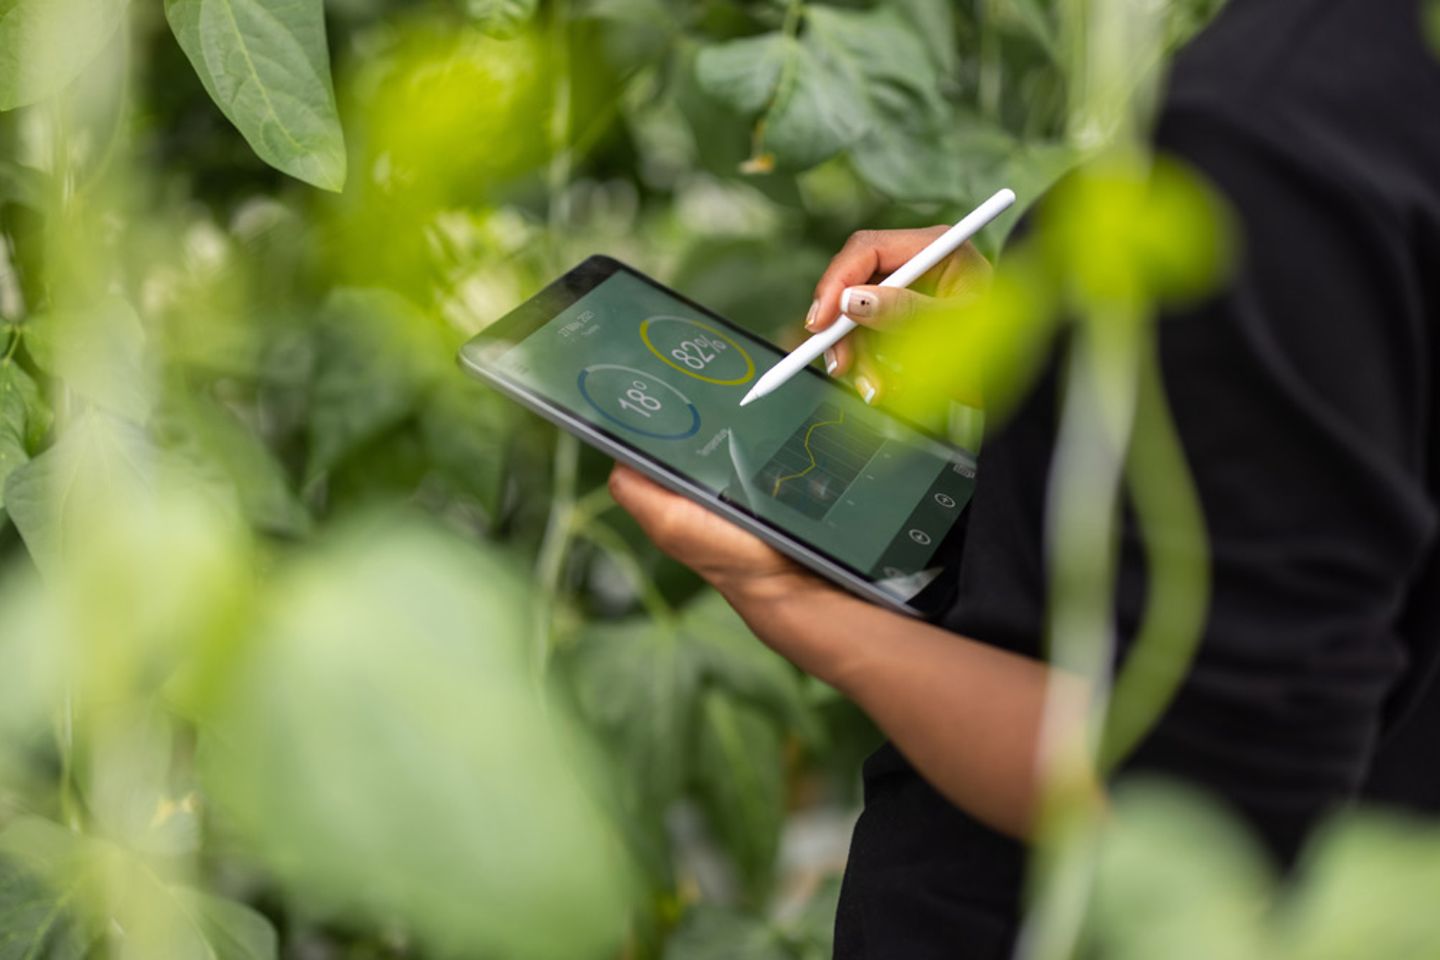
[458, 255, 973, 619]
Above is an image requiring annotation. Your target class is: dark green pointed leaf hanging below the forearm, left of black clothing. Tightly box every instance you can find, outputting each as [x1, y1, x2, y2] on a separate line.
[696, 691, 785, 904]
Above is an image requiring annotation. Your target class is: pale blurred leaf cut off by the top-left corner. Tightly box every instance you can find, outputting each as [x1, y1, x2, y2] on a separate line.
[0, 0, 127, 111]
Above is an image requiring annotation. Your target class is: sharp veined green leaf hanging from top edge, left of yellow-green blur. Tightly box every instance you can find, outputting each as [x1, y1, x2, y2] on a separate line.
[166, 0, 346, 190]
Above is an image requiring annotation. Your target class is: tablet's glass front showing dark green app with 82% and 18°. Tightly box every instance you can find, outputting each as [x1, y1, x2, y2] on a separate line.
[498, 272, 975, 597]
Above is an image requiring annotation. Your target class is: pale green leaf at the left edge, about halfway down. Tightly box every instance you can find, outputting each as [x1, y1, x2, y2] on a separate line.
[4, 410, 153, 571]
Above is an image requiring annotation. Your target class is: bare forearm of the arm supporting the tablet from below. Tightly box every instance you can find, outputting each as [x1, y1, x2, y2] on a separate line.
[721, 586, 1080, 838]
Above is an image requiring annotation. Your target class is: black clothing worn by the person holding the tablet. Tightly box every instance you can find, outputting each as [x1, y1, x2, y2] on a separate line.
[835, 0, 1440, 960]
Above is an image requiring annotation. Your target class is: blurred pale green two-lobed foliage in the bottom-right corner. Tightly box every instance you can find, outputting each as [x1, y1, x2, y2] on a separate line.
[1092, 783, 1440, 960]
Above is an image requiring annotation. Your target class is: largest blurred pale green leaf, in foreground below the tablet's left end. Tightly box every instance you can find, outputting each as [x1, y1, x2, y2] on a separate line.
[202, 522, 629, 960]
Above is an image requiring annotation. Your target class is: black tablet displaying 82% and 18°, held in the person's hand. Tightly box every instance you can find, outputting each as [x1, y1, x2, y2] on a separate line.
[459, 256, 975, 616]
